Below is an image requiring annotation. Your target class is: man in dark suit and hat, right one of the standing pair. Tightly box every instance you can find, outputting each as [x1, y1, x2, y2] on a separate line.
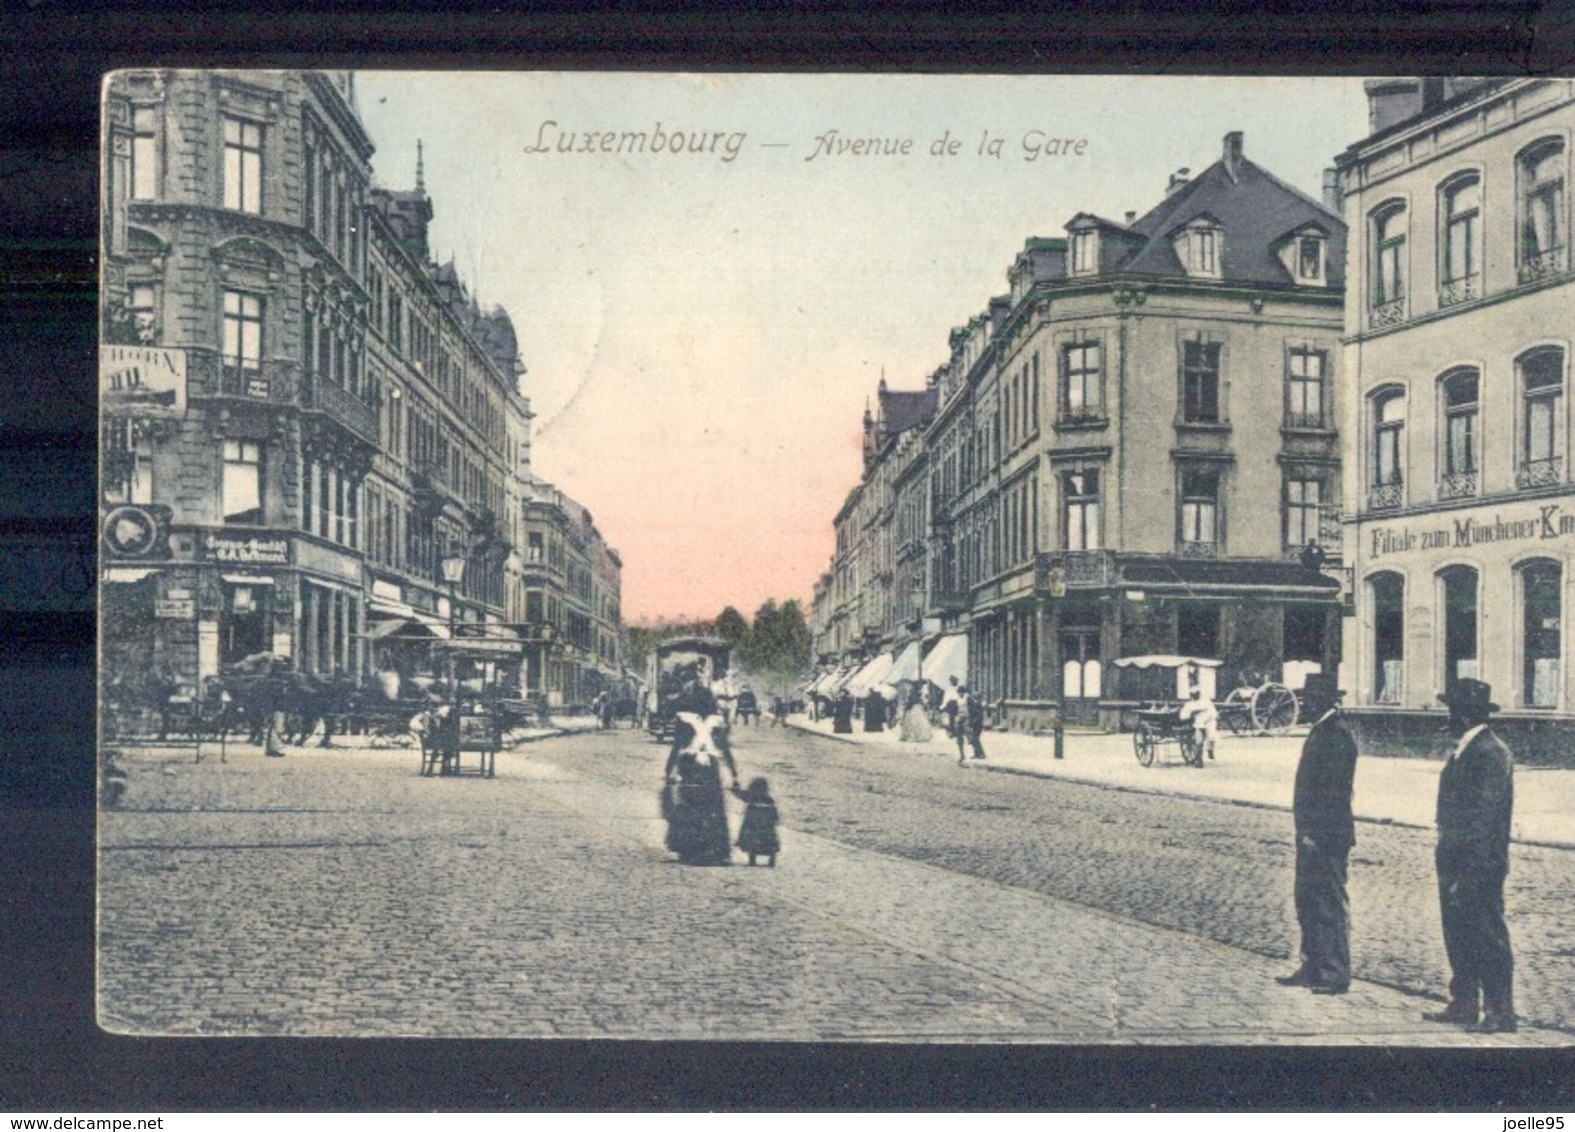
[1422, 680, 1517, 1033]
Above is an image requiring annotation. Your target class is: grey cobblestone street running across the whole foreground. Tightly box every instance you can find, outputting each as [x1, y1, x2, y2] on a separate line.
[99, 729, 1575, 1045]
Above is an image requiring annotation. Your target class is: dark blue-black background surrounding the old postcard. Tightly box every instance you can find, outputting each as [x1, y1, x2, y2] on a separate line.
[0, 0, 1575, 1108]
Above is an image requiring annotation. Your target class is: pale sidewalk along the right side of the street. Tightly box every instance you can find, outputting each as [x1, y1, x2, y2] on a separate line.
[788, 715, 1575, 849]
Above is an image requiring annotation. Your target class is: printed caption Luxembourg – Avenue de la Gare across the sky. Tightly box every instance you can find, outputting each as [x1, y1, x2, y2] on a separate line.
[524, 118, 1088, 164]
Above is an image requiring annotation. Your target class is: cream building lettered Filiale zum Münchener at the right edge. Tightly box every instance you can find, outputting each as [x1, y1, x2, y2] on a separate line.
[1339, 79, 1575, 757]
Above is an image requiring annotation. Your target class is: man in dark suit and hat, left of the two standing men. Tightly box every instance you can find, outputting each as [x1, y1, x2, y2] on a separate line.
[1277, 674, 1356, 995]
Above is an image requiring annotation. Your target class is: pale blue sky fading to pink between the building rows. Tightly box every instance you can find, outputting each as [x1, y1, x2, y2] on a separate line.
[356, 71, 1367, 620]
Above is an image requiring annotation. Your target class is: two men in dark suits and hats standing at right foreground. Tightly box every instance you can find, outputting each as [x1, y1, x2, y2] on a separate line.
[1279, 675, 1518, 1033]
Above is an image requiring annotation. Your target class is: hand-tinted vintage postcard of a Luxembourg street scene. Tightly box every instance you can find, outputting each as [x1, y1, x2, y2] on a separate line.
[96, 68, 1575, 1047]
